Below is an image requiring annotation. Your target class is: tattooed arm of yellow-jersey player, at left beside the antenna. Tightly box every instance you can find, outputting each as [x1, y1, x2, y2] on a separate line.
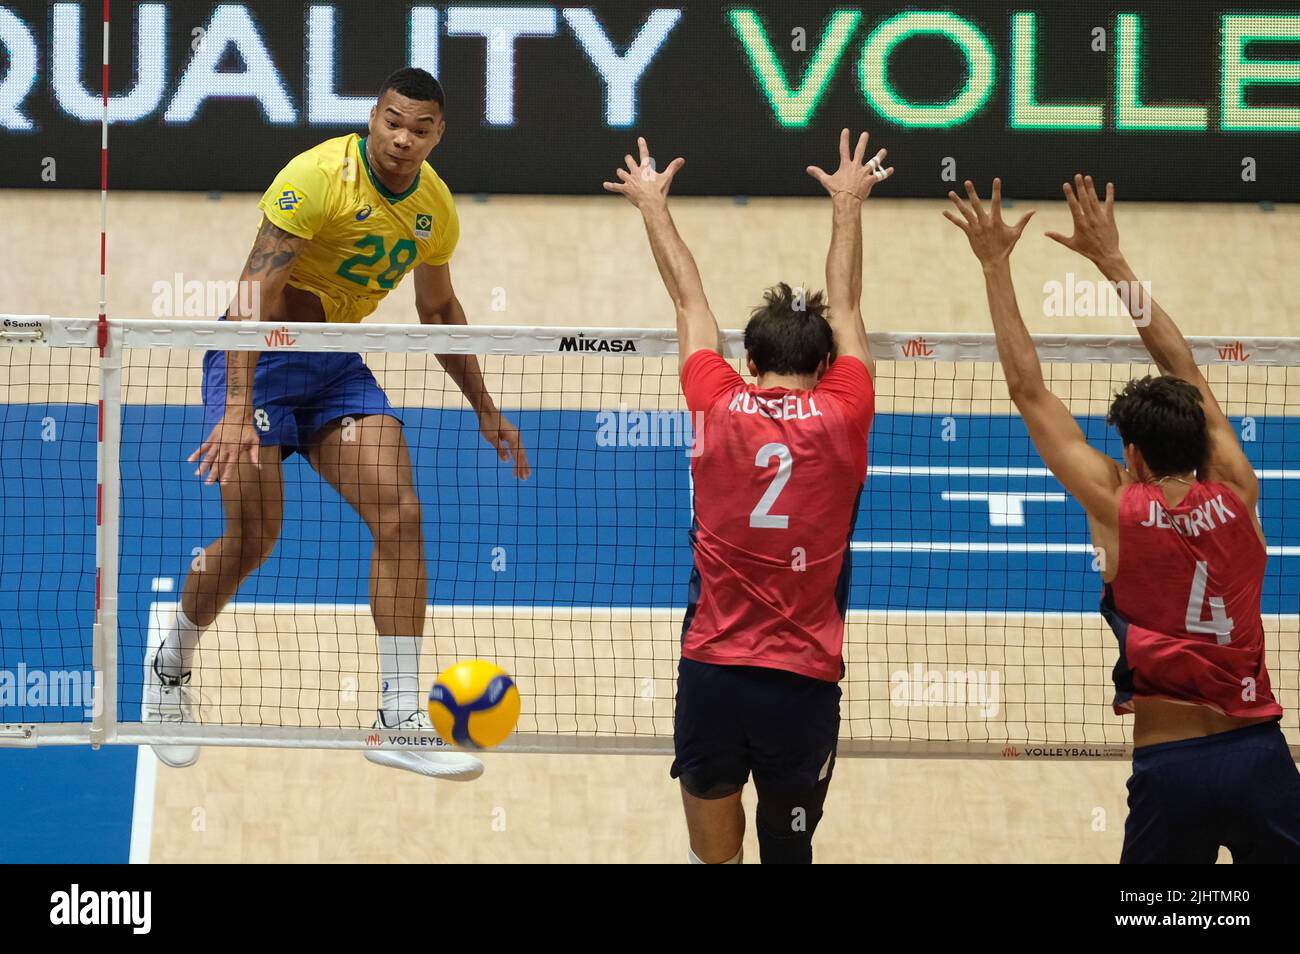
[190, 217, 308, 483]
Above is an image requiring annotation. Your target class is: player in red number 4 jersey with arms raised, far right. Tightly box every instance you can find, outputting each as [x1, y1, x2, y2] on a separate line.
[944, 175, 1300, 863]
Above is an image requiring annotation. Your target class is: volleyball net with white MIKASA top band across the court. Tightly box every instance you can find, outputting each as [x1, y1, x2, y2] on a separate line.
[0, 316, 1300, 759]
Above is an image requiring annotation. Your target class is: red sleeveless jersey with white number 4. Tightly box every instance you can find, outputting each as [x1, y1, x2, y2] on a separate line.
[1101, 481, 1282, 719]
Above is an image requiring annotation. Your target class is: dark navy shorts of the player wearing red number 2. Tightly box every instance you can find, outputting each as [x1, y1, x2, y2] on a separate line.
[671, 658, 840, 798]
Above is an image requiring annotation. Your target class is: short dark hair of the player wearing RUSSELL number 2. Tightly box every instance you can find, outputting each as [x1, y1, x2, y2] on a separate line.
[745, 282, 835, 374]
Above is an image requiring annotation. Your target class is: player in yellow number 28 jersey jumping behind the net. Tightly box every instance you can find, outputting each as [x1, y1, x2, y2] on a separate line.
[143, 69, 529, 780]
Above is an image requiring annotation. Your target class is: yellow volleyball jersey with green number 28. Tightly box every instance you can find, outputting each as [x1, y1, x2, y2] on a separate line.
[257, 133, 460, 327]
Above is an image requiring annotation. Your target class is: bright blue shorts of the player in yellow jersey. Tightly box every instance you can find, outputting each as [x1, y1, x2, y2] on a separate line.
[203, 351, 397, 456]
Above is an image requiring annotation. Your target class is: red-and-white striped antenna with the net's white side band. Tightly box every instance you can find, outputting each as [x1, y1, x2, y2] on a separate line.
[90, 0, 122, 747]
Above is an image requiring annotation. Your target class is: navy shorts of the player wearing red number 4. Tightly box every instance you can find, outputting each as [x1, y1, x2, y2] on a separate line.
[1119, 723, 1300, 864]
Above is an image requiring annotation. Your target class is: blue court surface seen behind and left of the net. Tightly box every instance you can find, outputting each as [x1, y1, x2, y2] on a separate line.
[0, 404, 1300, 862]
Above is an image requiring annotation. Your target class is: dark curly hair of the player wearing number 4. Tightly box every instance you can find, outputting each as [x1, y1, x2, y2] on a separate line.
[1106, 374, 1209, 477]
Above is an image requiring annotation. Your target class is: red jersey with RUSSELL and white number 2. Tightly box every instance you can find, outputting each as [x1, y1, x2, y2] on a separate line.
[681, 351, 875, 682]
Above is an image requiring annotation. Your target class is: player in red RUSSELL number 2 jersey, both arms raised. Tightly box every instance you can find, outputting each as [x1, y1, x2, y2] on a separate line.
[605, 130, 893, 863]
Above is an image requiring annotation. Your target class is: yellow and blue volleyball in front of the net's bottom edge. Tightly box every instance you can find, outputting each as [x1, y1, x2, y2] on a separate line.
[429, 659, 519, 749]
